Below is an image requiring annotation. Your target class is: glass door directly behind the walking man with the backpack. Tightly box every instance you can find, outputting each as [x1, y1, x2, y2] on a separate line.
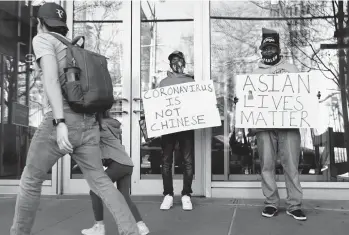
[61, 0, 131, 194]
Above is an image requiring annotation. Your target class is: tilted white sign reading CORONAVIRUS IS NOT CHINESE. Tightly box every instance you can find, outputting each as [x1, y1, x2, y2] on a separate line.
[142, 81, 221, 138]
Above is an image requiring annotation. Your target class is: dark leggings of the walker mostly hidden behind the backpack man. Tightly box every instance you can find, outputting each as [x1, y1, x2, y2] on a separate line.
[90, 161, 142, 222]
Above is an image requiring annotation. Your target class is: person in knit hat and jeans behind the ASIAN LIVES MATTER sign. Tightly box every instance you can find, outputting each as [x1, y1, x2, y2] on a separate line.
[252, 28, 307, 220]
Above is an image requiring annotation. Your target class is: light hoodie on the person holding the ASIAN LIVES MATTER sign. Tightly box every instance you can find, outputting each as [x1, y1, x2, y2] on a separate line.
[250, 57, 299, 134]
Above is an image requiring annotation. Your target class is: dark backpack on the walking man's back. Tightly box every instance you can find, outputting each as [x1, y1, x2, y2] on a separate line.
[49, 33, 114, 113]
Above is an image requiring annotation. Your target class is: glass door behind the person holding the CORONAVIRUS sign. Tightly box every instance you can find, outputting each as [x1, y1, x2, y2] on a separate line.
[131, 1, 203, 195]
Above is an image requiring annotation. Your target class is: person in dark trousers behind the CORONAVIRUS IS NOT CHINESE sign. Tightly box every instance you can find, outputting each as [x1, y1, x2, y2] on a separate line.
[160, 51, 194, 210]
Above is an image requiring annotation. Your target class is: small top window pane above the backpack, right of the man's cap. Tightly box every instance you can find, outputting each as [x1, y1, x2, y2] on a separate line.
[74, 0, 123, 21]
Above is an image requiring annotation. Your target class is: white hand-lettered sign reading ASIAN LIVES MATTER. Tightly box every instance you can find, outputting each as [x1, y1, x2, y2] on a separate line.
[236, 73, 320, 128]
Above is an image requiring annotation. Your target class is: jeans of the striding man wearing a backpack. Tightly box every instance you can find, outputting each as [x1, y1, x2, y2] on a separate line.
[10, 109, 139, 235]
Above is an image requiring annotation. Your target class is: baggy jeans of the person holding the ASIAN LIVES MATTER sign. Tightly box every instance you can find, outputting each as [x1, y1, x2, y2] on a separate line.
[256, 129, 303, 211]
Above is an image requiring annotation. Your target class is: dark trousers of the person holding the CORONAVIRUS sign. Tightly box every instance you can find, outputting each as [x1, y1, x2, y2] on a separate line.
[161, 131, 194, 196]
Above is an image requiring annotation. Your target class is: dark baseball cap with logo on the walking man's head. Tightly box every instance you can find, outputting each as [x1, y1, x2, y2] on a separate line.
[37, 2, 68, 28]
